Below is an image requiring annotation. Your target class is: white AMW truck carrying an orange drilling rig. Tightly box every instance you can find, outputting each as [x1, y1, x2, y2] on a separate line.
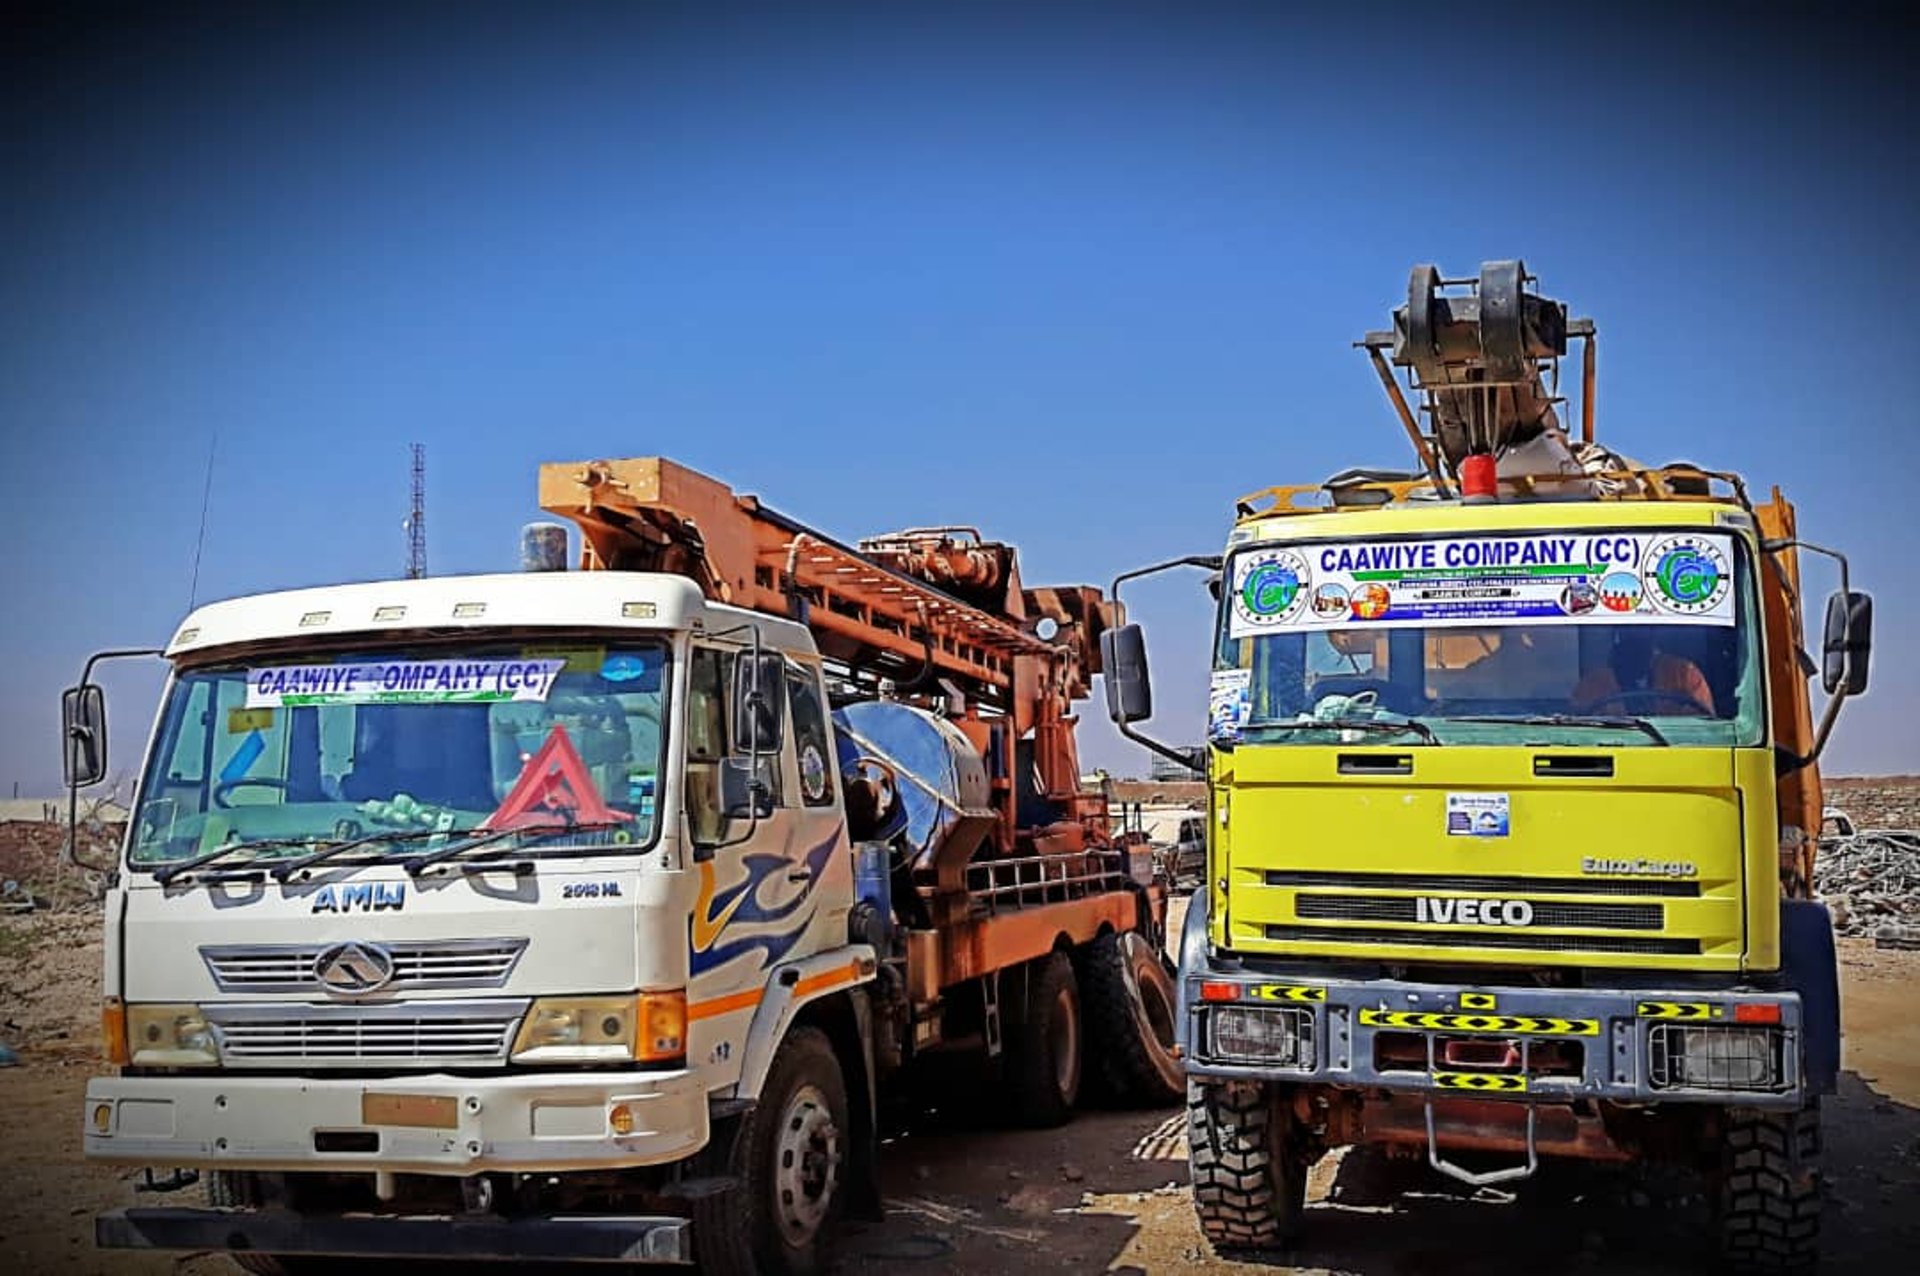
[63, 459, 1181, 1272]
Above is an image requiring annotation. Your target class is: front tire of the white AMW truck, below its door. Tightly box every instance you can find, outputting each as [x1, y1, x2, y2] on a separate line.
[693, 1027, 852, 1276]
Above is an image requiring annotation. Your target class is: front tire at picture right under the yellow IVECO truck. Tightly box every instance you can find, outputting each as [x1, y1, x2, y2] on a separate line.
[1718, 1107, 1820, 1272]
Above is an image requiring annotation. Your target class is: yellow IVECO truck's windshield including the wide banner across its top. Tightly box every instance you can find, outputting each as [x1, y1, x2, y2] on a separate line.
[1208, 530, 1764, 748]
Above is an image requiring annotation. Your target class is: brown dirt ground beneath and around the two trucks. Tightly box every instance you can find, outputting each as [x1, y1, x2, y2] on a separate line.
[0, 911, 1920, 1276]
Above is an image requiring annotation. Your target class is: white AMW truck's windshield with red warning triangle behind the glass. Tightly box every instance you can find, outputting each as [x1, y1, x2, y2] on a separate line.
[129, 643, 668, 867]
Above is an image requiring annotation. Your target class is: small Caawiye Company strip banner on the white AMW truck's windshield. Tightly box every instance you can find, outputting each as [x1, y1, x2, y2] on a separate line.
[246, 658, 566, 708]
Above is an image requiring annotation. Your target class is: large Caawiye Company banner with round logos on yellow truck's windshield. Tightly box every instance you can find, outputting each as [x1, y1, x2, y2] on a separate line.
[1227, 532, 1734, 639]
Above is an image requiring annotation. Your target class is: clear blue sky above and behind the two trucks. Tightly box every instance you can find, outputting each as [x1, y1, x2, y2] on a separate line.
[0, 4, 1920, 796]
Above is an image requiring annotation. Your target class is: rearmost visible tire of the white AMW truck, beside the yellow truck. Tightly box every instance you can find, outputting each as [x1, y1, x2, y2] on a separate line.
[1081, 931, 1187, 1107]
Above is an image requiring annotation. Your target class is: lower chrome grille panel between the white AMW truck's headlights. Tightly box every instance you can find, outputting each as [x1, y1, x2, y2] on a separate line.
[205, 1000, 528, 1067]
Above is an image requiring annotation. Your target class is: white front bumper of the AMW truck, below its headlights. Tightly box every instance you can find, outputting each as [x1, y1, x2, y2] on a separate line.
[81, 1071, 708, 1174]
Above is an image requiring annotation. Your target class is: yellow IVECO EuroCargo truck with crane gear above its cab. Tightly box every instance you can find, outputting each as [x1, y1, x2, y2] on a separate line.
[1104, 261, 1872, 1270]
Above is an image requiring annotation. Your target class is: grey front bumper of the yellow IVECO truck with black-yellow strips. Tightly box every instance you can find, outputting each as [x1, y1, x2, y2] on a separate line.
[1181, 967, 1809, 1109]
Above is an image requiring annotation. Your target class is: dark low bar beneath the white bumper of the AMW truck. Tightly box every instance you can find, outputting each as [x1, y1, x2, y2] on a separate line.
[94, 1209, 693, 1263]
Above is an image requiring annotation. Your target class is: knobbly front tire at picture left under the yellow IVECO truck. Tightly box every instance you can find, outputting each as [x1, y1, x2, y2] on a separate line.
[1187, 1078, 1308, 1249]
